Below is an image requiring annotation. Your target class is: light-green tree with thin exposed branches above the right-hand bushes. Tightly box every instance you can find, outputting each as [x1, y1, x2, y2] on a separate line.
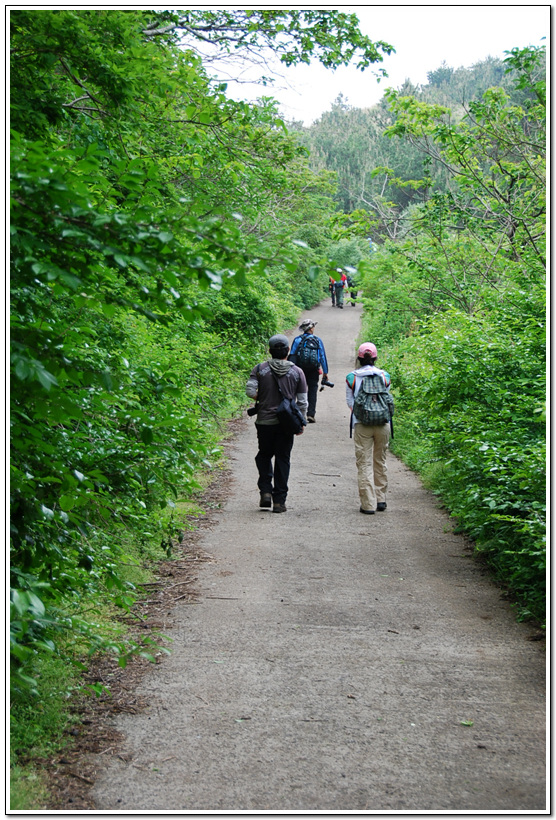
[387, 53, 546, 266]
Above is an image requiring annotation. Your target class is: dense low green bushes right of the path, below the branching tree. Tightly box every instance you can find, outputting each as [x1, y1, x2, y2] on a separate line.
[376, 293, 546, 619]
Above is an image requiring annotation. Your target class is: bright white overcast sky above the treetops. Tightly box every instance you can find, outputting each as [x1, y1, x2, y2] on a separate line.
[215, 5, 551, 125]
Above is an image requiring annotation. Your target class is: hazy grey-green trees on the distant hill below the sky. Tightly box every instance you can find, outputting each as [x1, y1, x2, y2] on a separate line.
[296, 52, 542, 243]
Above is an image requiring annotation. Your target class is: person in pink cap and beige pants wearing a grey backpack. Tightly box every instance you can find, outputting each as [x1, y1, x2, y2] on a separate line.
[346, 342, 394, 515]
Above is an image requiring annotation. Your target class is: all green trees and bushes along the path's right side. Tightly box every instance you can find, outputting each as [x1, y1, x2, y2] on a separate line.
[360, 49, 546, 620]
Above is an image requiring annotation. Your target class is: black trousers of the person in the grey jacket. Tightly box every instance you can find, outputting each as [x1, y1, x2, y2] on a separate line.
[255, 424, 293, 504]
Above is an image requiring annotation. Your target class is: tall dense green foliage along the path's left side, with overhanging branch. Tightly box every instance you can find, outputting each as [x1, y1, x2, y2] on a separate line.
[10, 9, 368, 728]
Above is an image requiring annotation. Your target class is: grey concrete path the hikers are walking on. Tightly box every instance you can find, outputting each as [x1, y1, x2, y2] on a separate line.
[93, 301, 546, 814]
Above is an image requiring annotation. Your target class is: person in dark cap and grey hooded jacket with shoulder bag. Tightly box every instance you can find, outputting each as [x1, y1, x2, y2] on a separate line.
[245, 334, 307, 513]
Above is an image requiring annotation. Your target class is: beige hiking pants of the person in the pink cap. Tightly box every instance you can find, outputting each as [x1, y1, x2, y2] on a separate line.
[353, 423, 390, 510]
